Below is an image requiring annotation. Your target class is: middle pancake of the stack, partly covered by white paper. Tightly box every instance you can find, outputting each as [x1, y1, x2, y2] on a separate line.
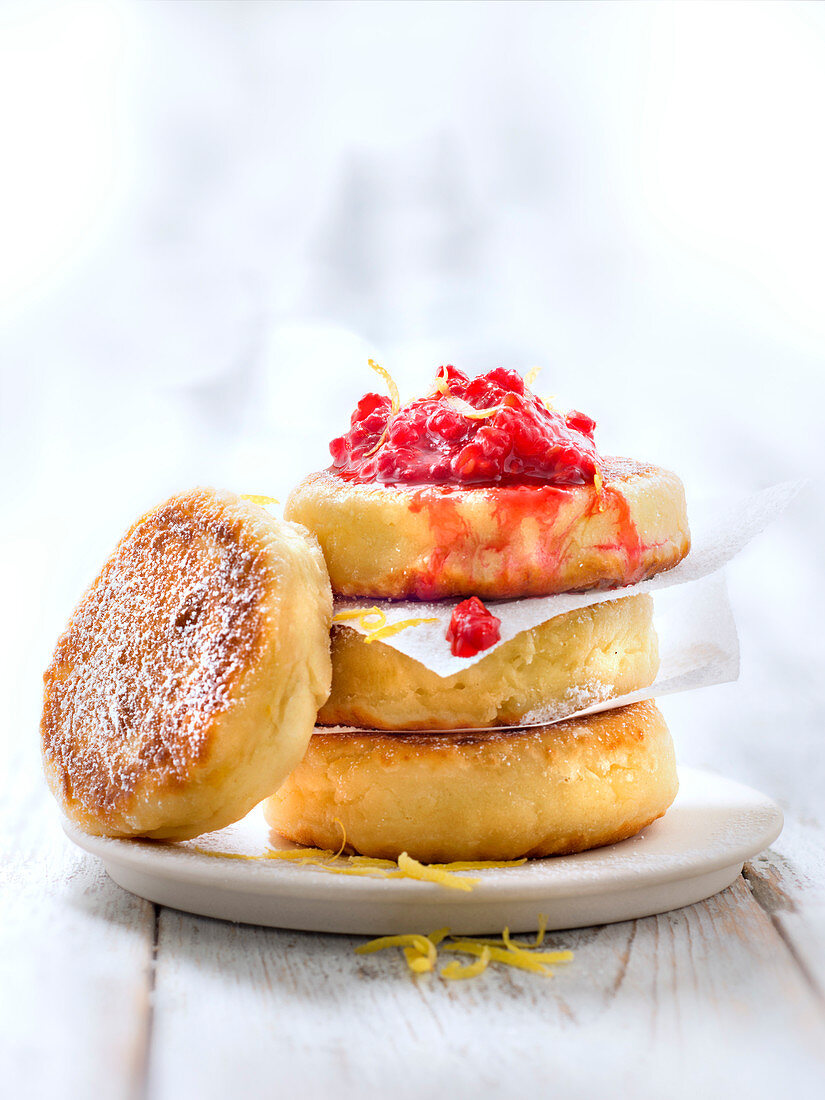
[318, 596, 659, 729]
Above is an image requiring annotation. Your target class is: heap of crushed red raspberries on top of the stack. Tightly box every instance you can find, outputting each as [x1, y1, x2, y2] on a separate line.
[330, 366, 598, 485]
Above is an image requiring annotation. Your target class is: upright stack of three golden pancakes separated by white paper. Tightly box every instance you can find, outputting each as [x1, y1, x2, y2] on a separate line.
[266, 460, 690, 862]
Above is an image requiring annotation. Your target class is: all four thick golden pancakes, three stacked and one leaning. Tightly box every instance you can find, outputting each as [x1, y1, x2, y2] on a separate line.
[42, 413, 690, 862]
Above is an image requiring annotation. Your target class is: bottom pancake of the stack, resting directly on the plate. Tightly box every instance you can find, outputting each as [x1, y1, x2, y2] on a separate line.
[265, 702, 678, 862]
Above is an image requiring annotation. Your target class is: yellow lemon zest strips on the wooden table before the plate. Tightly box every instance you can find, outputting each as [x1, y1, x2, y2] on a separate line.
[355, 915, 573, 981]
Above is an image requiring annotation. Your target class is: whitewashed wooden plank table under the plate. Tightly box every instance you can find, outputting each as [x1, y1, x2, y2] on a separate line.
[0, 501, 825, 1100]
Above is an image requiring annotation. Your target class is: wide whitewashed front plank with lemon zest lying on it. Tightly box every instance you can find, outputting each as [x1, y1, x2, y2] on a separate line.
[149, 866, 825, 1100]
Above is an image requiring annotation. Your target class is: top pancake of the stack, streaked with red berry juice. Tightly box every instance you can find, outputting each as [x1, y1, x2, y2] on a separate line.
[284, 459, 690, 600]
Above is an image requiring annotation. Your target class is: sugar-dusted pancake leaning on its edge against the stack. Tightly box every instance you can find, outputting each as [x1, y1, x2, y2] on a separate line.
[42, 490, 332, 839]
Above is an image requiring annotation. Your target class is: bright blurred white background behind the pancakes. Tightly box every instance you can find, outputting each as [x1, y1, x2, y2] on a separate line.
[0, 0, 825, 1087]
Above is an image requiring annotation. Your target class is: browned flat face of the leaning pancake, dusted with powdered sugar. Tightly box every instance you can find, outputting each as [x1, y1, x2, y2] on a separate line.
[42, 490, 266, 816]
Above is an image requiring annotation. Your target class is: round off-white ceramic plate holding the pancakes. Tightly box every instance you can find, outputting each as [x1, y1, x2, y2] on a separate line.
[64, 768, 782, 935]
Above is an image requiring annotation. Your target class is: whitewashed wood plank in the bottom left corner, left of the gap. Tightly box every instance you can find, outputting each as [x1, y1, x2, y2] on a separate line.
[0, 739, 155, 1100]
